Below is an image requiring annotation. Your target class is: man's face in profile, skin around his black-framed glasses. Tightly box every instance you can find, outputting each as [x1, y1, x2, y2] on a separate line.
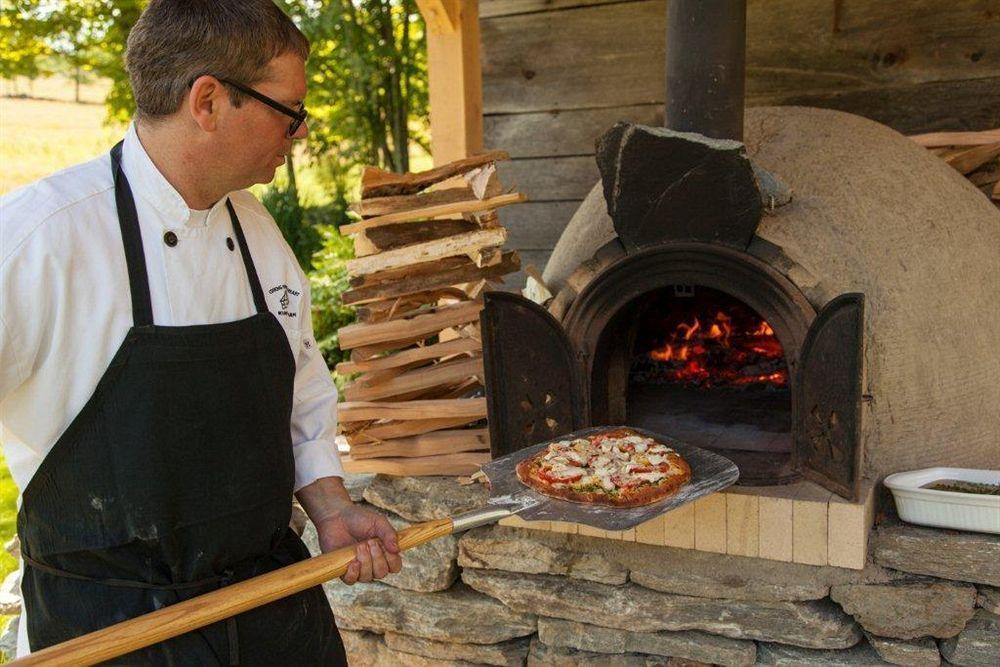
[224, 53, 309, 187]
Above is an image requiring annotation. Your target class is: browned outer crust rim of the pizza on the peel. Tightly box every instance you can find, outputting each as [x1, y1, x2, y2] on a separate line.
[516, 429, 691, 508]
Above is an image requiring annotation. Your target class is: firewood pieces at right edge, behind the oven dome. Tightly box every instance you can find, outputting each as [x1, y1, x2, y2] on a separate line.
[910, 129, 1000, 207]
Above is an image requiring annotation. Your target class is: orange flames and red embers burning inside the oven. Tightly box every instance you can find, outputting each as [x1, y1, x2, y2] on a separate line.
[648, 309, 788, 387]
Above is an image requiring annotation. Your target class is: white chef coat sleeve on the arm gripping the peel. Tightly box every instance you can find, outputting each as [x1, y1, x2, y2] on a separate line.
[291, 273, 344, 491]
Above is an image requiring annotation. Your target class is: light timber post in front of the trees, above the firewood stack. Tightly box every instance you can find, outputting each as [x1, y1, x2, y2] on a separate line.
[417, 0, 483, 165]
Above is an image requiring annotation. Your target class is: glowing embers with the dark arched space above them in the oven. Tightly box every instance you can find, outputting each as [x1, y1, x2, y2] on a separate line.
[631, 288, 788, 389]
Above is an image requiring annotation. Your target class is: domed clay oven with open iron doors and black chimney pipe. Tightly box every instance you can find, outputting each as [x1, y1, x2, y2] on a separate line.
[482, 0, 1000, 506]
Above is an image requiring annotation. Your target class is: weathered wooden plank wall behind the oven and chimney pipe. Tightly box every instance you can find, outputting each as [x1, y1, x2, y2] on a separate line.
[479, 0, 1000, 276]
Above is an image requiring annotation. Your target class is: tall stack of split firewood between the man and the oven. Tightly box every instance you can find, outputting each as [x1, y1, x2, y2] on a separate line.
[337, 151, 525, 475]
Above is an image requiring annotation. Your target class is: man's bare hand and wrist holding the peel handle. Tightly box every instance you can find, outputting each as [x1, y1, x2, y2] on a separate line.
[297, 477, 403, 584]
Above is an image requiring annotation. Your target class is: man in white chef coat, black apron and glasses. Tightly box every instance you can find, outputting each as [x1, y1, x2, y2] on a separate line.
[0, 0, 401, 665]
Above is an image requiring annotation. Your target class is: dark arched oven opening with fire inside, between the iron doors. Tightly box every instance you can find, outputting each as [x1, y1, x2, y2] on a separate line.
[625, 285, 796, 484]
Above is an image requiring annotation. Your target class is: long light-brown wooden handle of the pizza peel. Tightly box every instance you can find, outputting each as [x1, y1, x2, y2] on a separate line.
[9, 519, 452, 665]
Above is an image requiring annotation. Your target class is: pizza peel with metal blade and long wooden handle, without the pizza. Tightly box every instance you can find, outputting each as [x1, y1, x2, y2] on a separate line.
[9, 426, 739, 665]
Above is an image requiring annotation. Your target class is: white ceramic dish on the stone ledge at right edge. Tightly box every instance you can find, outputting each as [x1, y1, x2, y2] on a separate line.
[884, 468, 1000, 534]
